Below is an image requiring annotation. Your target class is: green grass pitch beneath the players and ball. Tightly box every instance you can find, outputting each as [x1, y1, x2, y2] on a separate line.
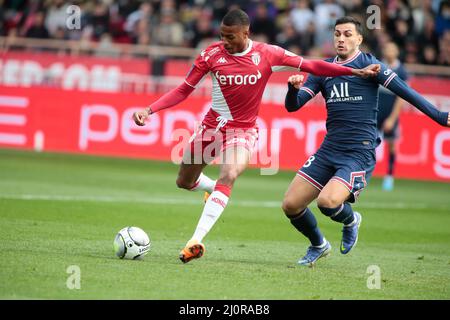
[0, 149, 450, 300]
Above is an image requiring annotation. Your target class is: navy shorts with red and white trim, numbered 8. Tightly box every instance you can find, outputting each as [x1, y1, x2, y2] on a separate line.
[297, 146, 376, 202]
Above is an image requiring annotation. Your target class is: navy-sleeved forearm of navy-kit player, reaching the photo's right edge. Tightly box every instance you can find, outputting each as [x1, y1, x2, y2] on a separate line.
[387, 76, 450, 127]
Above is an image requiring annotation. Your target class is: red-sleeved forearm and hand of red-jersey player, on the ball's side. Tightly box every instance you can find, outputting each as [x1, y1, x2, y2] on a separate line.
[133, 82, 194, 126]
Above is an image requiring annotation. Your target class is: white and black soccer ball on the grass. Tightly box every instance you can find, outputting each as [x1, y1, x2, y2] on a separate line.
[114, 227, 150, 260]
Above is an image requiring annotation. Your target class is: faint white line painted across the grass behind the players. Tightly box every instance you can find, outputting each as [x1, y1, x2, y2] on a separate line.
[0, 194, 450, 211]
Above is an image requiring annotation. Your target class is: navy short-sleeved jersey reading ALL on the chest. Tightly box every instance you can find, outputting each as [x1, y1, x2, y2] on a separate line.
[299, 52, 404, 149]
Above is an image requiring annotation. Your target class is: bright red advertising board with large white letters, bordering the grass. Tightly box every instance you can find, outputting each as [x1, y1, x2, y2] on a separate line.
[0, 87, 450, 181]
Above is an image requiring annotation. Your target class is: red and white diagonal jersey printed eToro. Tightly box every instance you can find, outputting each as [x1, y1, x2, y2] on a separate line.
[185, 40, 303, 128]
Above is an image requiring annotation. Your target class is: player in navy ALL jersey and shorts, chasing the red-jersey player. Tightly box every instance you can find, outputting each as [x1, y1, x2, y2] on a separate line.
[282, 17, 450, 266]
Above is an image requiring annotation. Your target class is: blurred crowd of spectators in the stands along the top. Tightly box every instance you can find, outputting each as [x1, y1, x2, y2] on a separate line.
[0, 0, 450, 66]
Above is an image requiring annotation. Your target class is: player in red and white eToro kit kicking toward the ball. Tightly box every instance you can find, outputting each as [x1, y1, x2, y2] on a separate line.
[133, 9, 379, 263]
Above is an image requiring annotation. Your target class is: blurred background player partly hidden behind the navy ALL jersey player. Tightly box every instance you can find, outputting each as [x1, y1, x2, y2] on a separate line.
[377, 42, 408, 191]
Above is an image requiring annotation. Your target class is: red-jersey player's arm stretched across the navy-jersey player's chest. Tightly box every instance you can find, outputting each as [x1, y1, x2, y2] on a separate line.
[300, 59, 381, 78]
